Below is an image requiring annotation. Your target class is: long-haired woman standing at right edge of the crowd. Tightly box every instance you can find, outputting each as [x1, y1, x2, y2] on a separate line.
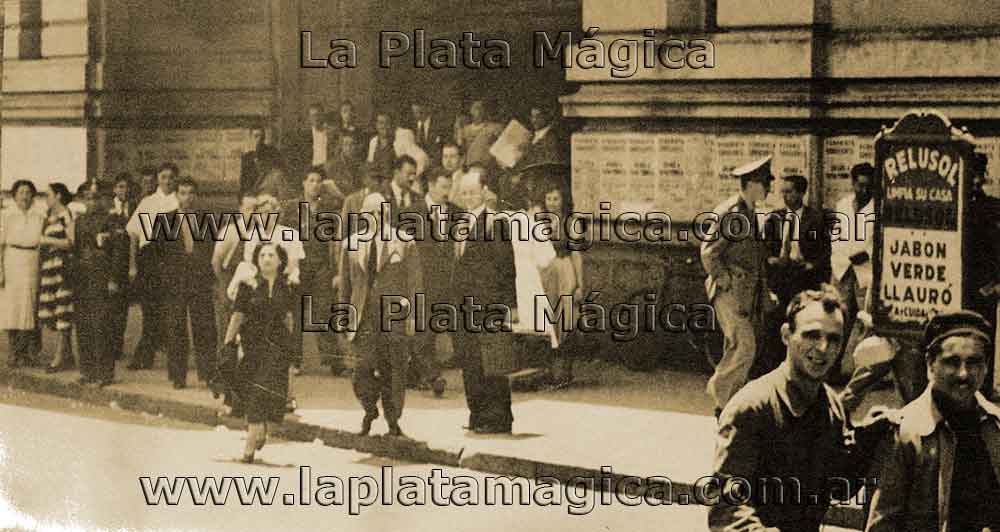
[540, 185, 584, 387]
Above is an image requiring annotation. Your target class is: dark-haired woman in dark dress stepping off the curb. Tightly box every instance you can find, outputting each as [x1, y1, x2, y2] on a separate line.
[226, 243, 296, 463]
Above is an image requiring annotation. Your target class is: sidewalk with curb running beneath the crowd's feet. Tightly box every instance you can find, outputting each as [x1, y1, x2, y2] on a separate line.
[0, 318, 891, 528]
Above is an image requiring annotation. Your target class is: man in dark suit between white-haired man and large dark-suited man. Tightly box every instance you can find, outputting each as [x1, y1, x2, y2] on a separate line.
[404, 169, 459, 397]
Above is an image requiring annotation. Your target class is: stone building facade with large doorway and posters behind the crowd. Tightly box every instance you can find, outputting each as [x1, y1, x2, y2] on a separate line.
[0, 0, 1000, 366]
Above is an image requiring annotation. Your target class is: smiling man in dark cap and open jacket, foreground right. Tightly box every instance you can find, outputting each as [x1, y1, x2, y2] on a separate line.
[866, 311, 1000, 532]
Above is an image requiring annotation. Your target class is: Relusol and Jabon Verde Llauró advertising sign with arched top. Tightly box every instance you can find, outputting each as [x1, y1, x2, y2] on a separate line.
[874, 111, 973, 334]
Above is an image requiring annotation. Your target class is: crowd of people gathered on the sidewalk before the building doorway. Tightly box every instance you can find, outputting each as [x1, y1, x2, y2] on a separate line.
[0, 97, 583, 455]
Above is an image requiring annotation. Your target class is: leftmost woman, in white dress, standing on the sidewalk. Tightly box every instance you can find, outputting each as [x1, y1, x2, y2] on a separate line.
[0, 180, 45, 367]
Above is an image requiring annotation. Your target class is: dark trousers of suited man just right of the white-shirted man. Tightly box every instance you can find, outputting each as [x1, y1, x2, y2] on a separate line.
[164, 285, 217, 382]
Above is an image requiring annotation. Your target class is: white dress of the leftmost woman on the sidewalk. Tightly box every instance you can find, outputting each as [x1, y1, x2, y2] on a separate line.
[0, 206, 45, 330]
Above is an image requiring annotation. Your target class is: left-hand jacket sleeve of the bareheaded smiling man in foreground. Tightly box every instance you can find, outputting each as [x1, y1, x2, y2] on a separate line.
[708, 403, 768, 532]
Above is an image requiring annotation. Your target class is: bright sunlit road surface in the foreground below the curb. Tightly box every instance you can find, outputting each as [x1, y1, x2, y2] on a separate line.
[0, 391, 728, 532]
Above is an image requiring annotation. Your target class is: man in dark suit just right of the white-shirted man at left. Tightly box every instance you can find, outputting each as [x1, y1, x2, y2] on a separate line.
[163, 177, 217, 389]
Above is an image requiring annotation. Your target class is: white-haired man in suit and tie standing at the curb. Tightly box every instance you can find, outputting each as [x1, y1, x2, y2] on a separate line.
[335, 193, 423, 437]
